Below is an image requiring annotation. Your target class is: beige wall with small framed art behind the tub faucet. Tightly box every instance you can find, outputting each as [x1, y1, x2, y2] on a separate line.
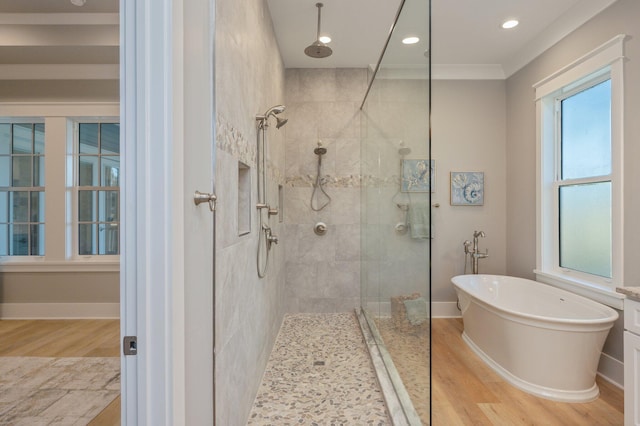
[431, 80, 507, 302]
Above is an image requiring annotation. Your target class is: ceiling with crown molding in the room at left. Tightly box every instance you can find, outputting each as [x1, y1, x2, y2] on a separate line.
[0, 0, 119, 82]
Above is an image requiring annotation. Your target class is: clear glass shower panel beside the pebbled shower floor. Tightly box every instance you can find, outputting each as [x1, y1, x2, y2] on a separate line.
[361, 0, 434, 424]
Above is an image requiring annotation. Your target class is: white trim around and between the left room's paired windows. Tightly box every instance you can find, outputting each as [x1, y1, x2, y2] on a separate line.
[0, 102, 120, 272]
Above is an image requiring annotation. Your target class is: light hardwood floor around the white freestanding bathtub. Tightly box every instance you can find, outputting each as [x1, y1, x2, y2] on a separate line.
[432, 319, 624, 426]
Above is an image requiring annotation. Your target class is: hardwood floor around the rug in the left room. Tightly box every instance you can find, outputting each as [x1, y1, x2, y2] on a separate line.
[0, 320, 120, 426]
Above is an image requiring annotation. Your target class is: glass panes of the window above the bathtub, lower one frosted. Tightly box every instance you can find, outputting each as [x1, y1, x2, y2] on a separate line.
[556, 79, 612, 278]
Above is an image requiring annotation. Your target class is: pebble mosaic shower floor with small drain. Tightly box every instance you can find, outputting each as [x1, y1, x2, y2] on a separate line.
[248, 312, 391, 426]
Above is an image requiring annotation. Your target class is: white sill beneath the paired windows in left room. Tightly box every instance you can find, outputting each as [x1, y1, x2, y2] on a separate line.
[0, 257, 120, 273]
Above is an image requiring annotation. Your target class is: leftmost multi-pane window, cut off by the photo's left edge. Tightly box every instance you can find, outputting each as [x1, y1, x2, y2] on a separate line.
[0, 123, 45, 256]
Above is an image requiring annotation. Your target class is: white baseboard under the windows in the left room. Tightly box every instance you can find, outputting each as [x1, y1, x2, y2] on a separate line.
[0, 303, 120, 319]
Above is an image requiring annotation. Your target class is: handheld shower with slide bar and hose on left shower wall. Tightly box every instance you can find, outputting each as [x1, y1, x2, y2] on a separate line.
[256, 105, 287, 278]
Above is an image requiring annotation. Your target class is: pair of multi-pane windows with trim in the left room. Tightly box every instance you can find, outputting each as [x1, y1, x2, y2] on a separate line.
[0, 107, 121, 274]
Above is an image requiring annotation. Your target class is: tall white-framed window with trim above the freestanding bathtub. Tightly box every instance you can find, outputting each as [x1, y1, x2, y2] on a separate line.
[534, 36, 625, 309]
